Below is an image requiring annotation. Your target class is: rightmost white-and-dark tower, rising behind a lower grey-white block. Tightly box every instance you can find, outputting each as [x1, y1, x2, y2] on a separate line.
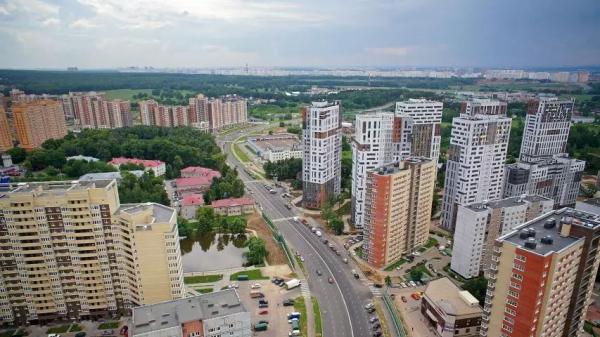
[520, 97, 574, 163]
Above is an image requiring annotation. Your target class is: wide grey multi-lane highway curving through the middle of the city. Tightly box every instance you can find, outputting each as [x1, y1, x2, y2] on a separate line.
[217, 126, 373, 337]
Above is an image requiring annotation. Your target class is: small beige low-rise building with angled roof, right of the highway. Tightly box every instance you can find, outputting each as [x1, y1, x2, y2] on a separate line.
[421, 277, 483, 337]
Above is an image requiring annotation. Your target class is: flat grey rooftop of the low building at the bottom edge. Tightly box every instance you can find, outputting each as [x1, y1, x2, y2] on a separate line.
[132, 289, 246, 335]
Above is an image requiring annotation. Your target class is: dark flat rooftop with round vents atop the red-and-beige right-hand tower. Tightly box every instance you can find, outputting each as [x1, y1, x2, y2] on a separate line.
[498, 208, 600, 255]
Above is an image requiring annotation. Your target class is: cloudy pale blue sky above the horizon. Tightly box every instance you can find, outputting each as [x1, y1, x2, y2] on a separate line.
[0, 0, 600, 68]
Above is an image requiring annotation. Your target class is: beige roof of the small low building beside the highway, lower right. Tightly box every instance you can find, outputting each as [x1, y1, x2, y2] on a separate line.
[425, 277, 482, 316]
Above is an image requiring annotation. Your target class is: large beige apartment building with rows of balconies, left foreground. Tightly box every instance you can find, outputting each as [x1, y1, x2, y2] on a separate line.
[0, 180, 184, 325]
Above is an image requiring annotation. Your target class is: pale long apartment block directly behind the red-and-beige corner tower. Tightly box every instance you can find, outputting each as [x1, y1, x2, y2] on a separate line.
[450, 195, 554, 279]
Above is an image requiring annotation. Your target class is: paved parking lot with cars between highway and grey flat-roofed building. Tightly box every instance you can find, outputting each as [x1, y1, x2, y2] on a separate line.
[238, 280, 301, 337]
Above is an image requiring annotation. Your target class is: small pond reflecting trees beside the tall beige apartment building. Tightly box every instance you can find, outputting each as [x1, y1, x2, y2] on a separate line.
[179, 232, 248, 273]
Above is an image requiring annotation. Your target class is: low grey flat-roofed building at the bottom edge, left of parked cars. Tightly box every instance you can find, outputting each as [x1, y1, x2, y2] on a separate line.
[131, 289, 252, 337]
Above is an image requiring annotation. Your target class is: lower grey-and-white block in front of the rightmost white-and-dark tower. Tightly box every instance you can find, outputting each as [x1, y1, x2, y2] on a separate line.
[504, 153, 585, 208]
